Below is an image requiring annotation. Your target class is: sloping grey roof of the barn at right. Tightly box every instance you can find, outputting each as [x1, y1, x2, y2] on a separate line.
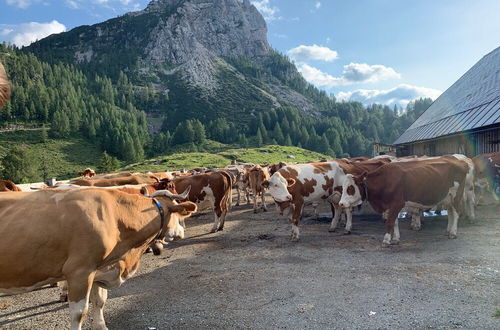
[394, 47, 500, 144]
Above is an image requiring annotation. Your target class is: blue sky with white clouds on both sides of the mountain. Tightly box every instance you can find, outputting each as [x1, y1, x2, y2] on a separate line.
[0, 0, 500, 106]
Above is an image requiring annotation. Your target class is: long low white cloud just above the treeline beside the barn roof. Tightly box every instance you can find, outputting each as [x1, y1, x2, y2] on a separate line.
[336, 84, 441, 107]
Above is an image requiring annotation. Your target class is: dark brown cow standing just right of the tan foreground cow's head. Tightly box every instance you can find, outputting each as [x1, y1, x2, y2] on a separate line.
[172, 171, 233, 233]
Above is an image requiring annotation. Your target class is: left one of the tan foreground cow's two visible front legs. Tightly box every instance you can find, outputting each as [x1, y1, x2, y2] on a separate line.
[67, 273, 94, 330]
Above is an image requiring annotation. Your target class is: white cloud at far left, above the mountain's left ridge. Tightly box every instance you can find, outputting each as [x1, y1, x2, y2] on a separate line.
[0, 20, 66, 47]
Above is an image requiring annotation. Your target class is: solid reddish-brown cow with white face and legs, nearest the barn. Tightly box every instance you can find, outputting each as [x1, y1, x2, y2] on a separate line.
[339, 156, 469, 246]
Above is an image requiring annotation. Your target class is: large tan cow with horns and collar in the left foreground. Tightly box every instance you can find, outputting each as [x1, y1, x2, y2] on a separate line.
[0, 189, 196, 329]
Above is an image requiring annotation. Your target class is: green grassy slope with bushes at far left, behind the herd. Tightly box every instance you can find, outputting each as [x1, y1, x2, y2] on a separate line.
[0, 130, 101, 181]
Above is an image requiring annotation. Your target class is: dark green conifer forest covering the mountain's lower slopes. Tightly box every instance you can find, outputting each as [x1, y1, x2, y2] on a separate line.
[0, 45, 431, 162]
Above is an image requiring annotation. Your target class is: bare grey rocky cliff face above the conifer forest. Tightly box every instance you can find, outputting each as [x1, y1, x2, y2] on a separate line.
[28, 0, 315, 122]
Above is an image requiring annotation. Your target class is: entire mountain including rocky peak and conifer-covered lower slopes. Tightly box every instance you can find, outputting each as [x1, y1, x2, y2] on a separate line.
[0, 0, 430, 163]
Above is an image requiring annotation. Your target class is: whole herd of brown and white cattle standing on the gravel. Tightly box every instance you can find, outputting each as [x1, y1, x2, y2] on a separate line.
[0, 153, 500, 329]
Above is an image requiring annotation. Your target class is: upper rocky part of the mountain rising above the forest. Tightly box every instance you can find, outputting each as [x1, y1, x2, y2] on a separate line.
[25, 0, 320, 127]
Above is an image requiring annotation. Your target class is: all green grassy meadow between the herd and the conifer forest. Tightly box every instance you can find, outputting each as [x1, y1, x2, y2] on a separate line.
[0, 130, 327, 181]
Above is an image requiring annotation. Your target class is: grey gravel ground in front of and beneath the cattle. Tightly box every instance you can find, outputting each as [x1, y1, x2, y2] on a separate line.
[0, 196, 500, 329]
